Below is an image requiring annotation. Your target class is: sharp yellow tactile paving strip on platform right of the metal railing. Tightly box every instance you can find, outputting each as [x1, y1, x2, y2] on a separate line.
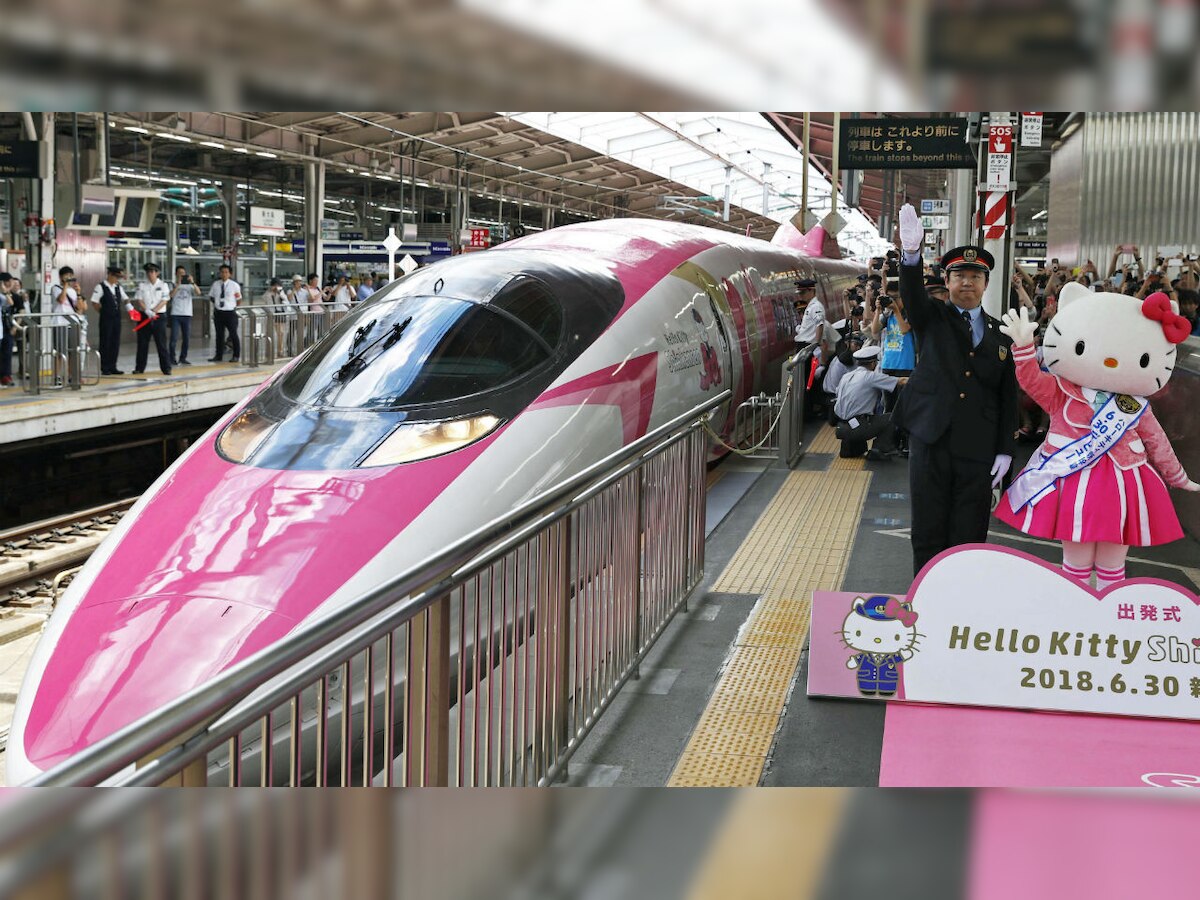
[667, 470, 871, 787]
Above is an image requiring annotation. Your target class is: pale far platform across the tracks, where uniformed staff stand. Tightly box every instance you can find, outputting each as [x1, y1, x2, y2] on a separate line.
[0, 347, 282, 449]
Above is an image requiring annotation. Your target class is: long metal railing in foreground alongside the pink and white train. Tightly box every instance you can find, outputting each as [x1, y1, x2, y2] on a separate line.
[34, 391, 730, 786]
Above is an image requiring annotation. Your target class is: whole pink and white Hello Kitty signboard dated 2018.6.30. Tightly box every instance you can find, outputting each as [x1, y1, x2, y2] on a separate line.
[809, 544, 1200, 720]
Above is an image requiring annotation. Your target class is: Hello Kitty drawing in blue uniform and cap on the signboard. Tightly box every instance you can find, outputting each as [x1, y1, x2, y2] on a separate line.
[841, 594, 922, 697]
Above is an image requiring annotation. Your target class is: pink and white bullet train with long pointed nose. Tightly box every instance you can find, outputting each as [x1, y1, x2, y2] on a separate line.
[6, 220, 862, 784]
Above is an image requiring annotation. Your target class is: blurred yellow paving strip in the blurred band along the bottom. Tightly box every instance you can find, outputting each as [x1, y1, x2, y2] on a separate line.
[686, 788, 846, 900]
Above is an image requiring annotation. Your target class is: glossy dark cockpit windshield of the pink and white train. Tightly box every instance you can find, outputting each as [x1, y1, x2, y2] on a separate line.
[280, 281, 562, 409]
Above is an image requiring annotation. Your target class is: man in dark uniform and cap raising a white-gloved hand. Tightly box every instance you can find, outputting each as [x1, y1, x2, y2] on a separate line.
[894, 203, 1016, 574]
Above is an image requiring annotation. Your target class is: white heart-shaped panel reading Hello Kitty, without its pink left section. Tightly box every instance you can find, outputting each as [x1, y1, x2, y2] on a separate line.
[904, 545, 1200, 719]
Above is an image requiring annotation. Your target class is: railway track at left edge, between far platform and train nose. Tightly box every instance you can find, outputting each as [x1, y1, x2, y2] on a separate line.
[0, 498, 136, 613]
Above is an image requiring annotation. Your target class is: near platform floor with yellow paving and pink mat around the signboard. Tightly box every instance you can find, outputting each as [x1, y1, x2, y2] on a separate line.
[568, 424, 1200, 787]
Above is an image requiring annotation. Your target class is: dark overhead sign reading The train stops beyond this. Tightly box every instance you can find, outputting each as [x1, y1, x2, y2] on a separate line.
[838, 119, 976, 169]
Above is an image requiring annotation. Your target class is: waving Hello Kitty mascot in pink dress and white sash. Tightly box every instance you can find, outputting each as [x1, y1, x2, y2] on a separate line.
[996, 283, 1200, 589]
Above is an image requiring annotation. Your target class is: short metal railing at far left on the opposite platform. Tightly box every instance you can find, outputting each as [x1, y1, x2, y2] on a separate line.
[13, 312, 100, 394]
